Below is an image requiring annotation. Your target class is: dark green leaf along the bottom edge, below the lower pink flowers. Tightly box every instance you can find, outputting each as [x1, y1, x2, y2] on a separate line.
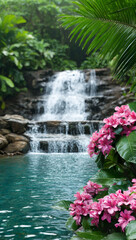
[76, 231, 105, 240]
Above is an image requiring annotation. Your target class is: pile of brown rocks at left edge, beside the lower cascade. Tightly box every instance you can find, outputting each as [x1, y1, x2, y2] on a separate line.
[0, 115, 30, 155]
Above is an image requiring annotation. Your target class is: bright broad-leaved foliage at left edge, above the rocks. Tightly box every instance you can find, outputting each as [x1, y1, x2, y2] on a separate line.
[0, 15, 54, 108]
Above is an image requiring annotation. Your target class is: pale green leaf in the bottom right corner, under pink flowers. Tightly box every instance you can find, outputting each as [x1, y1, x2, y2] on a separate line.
[126, 221, 136, 240]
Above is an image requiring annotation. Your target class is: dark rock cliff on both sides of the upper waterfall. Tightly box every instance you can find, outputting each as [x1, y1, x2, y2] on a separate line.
[0, 69, 131, 120]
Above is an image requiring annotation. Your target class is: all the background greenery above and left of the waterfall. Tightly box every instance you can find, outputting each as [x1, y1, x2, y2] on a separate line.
[0, 0, 108, 104]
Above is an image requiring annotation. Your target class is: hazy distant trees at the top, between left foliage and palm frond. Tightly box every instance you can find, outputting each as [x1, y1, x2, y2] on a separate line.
[0, 0, 85, 67]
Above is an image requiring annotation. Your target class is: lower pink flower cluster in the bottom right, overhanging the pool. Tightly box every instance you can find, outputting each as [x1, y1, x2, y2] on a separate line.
[70, 179, 136, 232]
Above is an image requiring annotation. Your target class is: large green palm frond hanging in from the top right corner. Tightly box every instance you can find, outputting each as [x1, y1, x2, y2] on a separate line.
[61, 0, 136, 79]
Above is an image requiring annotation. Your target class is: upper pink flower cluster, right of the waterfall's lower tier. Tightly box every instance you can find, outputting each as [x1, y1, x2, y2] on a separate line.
[88, 105, 136, 157]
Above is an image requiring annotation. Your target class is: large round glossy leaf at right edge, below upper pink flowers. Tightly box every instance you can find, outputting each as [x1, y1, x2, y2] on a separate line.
[116, 131, 136, 163]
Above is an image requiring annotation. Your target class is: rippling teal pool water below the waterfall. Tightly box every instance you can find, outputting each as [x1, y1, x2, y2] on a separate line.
[0, 153, 96, 240]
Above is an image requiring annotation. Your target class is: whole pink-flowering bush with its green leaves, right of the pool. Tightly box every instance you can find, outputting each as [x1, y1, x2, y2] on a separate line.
[57, 103, 136, 240]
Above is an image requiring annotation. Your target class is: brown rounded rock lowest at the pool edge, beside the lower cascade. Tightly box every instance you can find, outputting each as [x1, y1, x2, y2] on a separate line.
[3, 141, 30, 154]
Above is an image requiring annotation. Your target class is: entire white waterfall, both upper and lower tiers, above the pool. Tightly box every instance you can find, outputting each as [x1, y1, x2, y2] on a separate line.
[28, 70, 97, 153]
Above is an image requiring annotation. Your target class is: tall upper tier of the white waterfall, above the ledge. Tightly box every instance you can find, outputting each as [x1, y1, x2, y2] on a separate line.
[37, 70, 86, 121]
